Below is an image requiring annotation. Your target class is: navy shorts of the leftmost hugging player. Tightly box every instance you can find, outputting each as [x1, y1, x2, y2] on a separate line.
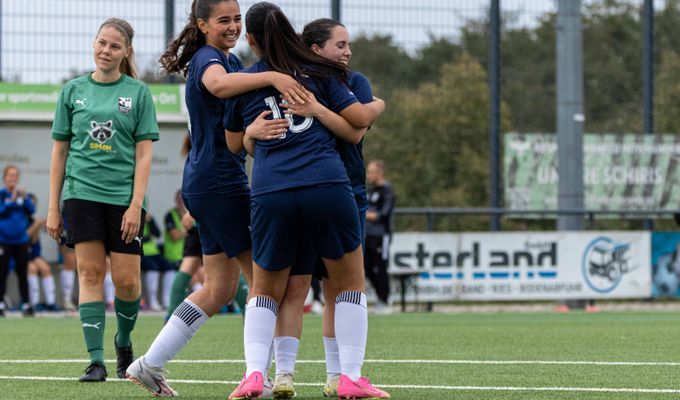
[184, 194, 251, 258]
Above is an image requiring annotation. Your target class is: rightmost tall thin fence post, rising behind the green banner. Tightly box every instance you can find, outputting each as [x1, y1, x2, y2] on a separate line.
[642, 0, 654, 231]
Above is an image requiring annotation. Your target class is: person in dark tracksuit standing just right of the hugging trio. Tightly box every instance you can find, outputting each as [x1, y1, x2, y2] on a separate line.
[364, 160, 395, 312]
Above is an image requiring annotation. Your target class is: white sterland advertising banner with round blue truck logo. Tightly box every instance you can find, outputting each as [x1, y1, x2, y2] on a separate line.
[389, 231, 652, 301]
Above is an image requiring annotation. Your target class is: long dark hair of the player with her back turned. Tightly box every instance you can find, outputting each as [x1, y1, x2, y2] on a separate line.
[246, 1, 349, 82]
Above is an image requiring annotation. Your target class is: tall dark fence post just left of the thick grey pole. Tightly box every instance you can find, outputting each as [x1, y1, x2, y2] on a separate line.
[487, 0, 501, 231]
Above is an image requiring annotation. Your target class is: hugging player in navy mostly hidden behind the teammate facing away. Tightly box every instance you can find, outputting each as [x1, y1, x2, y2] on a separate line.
[264, 18, 386, 396]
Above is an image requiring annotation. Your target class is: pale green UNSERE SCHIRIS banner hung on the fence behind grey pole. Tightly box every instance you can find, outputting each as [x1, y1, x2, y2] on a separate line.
[503, 133, 680, 212]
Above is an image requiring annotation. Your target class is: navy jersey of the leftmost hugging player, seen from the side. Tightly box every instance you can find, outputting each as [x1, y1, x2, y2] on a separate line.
[182, 45, 249, 198]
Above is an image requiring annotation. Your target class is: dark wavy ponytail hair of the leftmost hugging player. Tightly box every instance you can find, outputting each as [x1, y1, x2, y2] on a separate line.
[158, 0, 236, 77]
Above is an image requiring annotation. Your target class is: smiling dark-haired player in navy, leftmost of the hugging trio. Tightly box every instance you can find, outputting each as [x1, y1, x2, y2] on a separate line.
[127, 0, 304, 396]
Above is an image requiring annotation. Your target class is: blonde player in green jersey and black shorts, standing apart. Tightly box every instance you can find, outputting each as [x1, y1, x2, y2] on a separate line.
[47, 18, 158, 382]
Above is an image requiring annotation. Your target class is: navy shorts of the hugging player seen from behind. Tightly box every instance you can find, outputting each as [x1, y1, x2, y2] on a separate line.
[251, 184, 361, 275]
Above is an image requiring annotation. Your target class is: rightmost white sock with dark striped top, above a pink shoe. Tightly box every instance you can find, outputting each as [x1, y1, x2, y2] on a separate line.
[335, 291, 368, 381]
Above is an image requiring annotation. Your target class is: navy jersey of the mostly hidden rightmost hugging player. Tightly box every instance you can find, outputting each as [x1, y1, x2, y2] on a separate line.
[337, 72, 373, 211]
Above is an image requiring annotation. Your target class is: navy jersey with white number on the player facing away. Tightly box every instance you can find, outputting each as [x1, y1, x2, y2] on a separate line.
[224, 61, 357, 196]
